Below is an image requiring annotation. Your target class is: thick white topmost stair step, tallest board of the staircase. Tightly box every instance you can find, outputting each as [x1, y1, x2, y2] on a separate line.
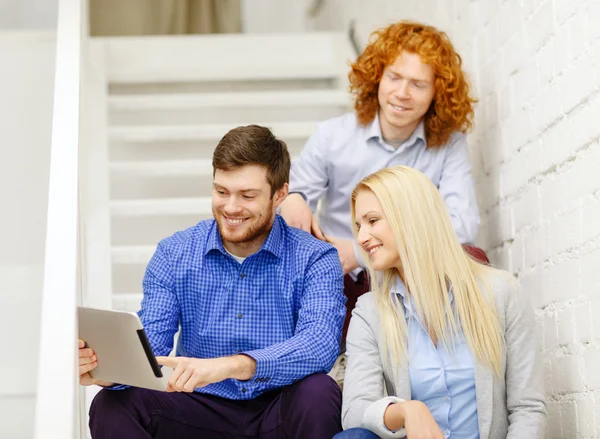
[102, 32, 351, 84]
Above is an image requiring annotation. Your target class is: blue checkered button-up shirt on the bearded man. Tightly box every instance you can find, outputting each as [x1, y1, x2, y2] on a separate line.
[139, 216, 346, 399]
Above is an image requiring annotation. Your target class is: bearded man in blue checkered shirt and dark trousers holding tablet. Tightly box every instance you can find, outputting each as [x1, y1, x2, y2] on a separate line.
[79, 125, 345, 439]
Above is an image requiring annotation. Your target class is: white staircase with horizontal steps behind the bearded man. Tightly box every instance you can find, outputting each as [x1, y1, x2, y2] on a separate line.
[79, 33, 352, 311]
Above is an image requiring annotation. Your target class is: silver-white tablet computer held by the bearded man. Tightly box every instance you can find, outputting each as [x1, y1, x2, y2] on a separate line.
[77, 306, 167, 390]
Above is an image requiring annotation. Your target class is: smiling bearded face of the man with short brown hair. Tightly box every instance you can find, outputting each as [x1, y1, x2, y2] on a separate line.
[212, 165, 288, 257]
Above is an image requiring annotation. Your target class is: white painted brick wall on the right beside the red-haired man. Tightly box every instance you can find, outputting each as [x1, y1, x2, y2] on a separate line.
[321, 0, 600, 438]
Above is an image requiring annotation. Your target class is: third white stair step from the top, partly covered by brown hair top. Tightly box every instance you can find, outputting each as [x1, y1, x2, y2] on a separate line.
[110, 121, 318, 145]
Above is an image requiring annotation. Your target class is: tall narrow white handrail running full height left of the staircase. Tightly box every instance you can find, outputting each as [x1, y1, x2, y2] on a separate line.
[35, 0, 82, 439]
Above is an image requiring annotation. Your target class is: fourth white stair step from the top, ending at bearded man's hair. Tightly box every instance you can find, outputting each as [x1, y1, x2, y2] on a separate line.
[110, 159, 212, 178]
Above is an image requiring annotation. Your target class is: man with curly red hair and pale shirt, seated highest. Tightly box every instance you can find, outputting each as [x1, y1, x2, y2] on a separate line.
[281, 22, 485, 358]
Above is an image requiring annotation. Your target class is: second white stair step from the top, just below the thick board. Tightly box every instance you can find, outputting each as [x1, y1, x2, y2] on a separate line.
[109, 89, 351, 112]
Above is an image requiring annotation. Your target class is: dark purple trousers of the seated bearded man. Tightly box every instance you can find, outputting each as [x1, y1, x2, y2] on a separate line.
[90, 374, 342, 439]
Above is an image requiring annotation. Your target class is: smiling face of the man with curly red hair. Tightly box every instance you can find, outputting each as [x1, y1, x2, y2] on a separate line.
[377, 52, 435, 141]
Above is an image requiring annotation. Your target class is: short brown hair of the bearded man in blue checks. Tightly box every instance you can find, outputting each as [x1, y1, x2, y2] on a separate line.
[213, 125, 291, 197]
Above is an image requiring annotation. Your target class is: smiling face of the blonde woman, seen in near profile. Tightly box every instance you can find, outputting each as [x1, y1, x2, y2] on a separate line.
[354, 189, 401, 271]
